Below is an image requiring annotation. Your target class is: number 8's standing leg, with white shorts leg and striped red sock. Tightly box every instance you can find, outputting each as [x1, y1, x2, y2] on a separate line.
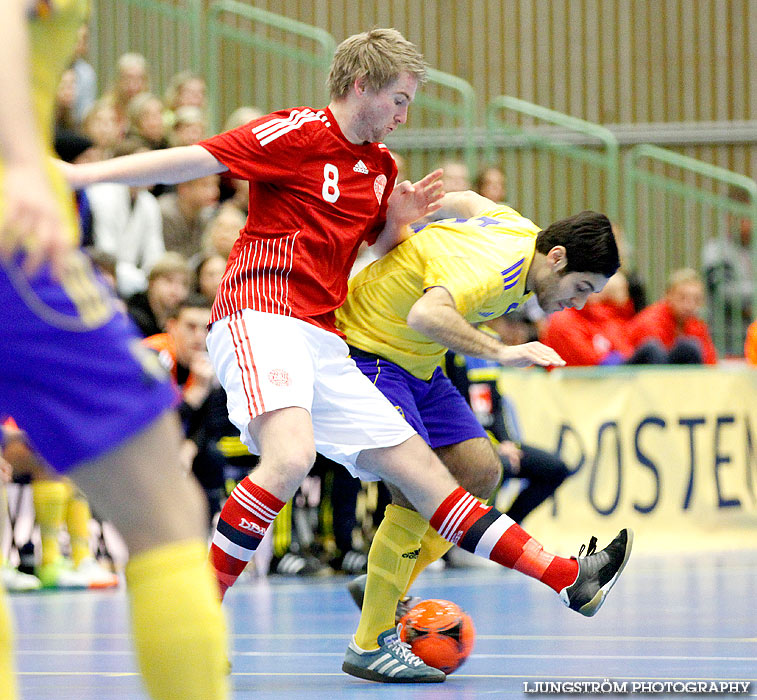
[207, 309, 318, 596]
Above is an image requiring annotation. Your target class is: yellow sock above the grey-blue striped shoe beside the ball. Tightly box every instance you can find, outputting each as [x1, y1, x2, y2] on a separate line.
[355, 505, 428, 650]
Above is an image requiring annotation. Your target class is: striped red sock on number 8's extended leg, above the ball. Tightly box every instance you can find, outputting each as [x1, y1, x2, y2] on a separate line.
[431, 487, 578, 593]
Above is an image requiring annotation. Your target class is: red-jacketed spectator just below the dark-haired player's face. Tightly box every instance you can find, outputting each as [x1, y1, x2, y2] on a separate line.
[541, 272, 633, 366]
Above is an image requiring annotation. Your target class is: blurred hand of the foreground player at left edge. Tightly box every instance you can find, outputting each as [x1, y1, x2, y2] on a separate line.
[0, 163, 75, 278]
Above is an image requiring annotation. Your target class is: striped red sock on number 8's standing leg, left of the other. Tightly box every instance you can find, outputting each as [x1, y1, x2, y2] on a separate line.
[210, 476, 284, 599]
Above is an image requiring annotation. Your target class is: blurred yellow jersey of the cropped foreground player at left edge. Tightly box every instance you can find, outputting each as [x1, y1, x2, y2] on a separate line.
[0, 0, 89, 242]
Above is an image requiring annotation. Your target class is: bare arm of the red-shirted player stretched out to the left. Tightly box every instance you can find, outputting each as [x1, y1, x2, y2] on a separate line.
[56, 145, 228, 189]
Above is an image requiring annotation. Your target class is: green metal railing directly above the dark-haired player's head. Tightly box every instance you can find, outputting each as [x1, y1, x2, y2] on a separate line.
[486, 95, 620, 223]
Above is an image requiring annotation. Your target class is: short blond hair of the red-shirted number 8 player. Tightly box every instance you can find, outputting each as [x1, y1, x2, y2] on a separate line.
[327, 29, 427, 99]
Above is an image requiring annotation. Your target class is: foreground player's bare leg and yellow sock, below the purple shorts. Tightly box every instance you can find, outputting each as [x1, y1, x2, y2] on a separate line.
[70, 414, 227, 700]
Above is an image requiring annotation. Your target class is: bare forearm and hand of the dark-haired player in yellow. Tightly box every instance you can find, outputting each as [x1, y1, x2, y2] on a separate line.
[407, 287, 565, 367]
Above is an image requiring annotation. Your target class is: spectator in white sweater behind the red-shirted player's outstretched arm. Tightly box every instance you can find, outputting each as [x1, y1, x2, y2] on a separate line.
[86, 140, 166, 298]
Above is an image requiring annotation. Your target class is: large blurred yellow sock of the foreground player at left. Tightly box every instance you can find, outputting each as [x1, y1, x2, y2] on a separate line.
[126, 540, 228, 700]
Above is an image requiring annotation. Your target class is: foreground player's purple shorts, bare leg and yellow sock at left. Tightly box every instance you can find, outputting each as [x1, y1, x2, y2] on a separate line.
[0, 254, 226, 700]
